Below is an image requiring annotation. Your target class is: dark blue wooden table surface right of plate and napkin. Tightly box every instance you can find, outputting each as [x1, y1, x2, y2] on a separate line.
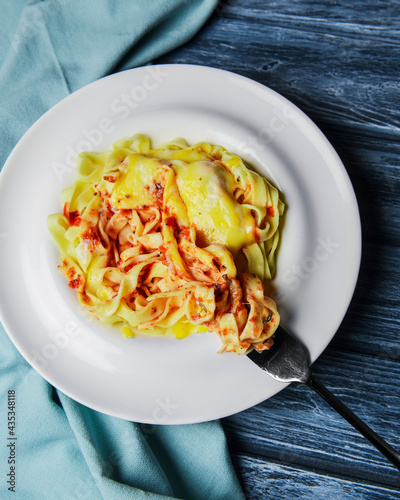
[155, 0, 400, 500]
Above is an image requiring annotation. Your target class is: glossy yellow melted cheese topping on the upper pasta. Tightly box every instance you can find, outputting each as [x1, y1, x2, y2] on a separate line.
[110, 154, 258, 254]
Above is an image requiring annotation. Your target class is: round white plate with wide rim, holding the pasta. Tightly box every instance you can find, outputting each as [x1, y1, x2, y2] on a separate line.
[0, 65, 361, 424]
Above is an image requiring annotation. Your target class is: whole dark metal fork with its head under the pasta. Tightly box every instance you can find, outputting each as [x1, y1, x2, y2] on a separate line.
[247, 327, 400, 470]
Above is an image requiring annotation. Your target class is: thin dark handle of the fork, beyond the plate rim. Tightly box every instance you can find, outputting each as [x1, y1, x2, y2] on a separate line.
[304, 373, 400, 470]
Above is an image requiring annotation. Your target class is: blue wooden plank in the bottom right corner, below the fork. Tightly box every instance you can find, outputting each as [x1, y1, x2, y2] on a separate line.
[233, 453, 400, 500]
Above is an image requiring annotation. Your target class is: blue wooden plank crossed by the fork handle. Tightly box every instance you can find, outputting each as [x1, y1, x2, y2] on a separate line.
[222, 352, 400, 487]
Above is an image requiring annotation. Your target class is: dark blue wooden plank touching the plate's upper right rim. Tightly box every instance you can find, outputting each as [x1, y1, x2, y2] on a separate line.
[161, 3, 400, 136]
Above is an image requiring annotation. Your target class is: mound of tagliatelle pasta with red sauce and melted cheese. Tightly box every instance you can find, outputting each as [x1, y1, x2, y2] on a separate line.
[48, 134, 284, 354]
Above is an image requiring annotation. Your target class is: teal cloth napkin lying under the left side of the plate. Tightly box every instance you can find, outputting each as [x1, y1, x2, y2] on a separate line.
[0, 0, 244, 500]
